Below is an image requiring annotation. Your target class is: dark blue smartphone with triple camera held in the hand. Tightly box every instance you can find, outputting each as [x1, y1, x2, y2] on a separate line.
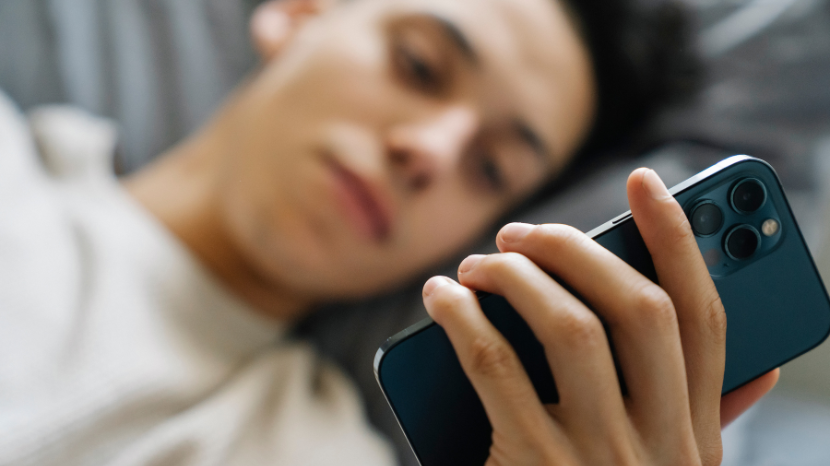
[374, 155, 830, 466]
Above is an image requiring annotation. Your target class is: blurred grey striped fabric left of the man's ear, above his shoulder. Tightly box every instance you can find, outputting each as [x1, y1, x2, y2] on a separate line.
[0, 0, 255, 171]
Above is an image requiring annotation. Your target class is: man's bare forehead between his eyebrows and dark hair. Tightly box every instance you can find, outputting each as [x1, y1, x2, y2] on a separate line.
[368, 0, 595, 167]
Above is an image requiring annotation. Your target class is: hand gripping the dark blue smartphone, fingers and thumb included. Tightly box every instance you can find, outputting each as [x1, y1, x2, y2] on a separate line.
[424, 169, 778, 466]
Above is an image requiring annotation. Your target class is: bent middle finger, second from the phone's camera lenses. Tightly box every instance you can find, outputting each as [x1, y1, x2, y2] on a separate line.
[497, 224, 692, 442]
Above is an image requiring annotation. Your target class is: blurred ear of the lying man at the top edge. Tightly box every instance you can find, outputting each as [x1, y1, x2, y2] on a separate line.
[251, 0, 333, 61]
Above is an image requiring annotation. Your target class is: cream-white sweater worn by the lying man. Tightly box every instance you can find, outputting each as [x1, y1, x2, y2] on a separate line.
[0, 93, 395, 466]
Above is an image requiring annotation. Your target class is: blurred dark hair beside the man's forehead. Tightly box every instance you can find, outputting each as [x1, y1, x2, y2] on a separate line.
[554, 0, 702, 159]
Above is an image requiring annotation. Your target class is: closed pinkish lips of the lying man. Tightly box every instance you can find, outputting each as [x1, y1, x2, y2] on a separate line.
[326, 157, 392, 242]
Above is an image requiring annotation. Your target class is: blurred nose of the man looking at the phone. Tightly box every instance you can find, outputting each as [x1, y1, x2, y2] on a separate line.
[388, 106, 479, 191]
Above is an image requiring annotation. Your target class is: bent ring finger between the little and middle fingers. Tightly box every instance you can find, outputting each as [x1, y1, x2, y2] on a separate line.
[458, 254, 627, 435]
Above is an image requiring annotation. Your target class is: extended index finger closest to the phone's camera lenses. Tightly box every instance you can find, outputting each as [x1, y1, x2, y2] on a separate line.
[628, 168, 726, 454]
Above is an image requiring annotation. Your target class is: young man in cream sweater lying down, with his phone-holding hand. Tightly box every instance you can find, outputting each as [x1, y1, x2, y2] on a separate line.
[0, 0, 774, 465]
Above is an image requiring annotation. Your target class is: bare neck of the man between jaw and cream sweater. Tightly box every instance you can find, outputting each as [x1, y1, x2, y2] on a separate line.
[124, 109, 313, 321]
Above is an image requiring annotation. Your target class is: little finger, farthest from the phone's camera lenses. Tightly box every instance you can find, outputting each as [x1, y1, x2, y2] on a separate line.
[423, 277, 556, 446]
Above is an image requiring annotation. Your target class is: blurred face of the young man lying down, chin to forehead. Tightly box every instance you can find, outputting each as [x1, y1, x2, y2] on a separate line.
[222, 0, 594, 299]
